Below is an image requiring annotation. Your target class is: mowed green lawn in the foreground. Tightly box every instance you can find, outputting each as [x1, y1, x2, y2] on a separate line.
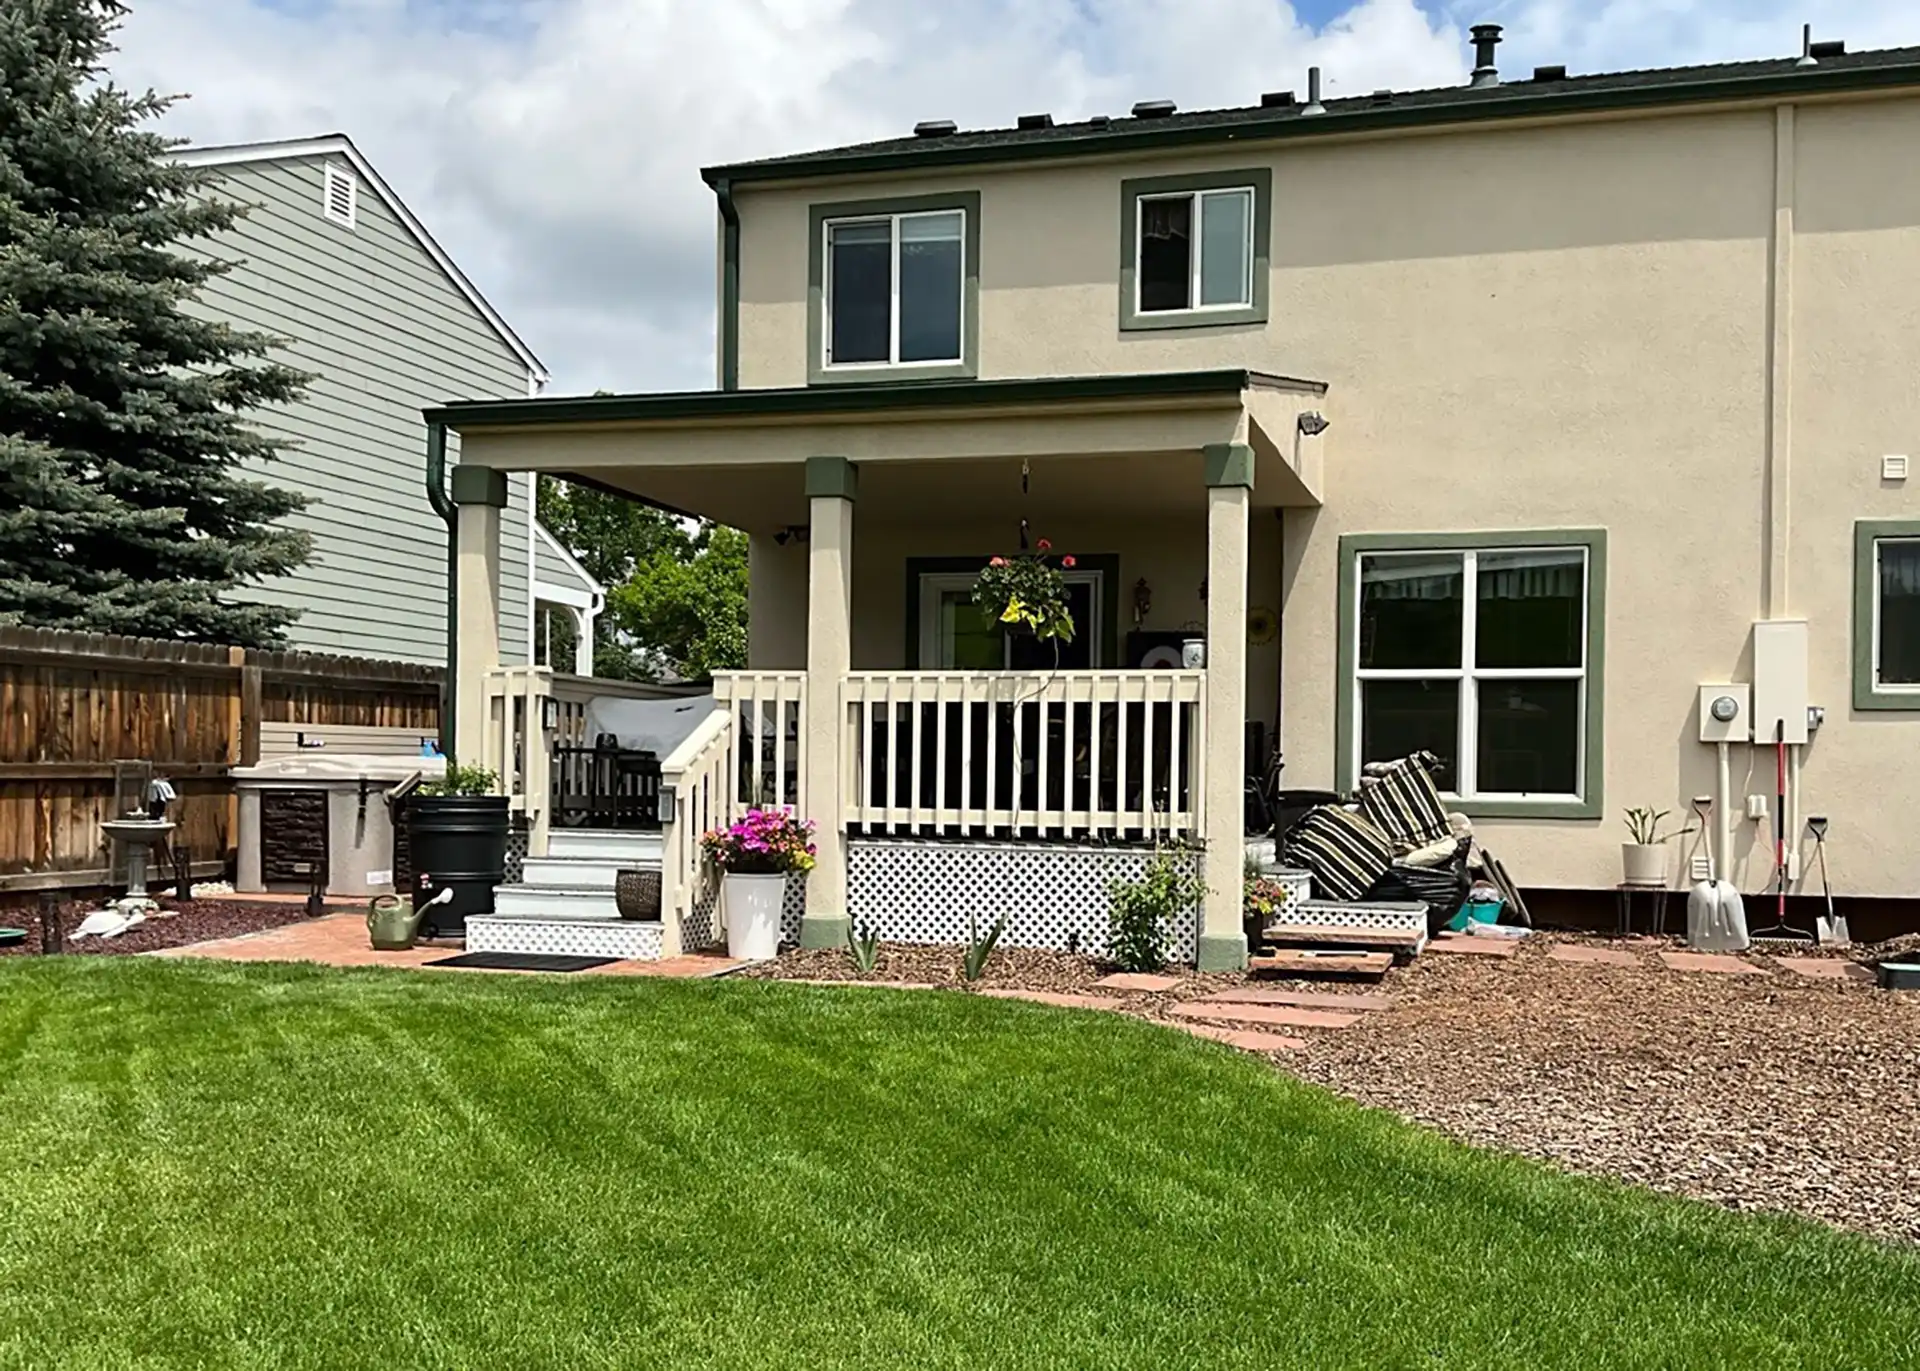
[0, 958, 1920, 1371]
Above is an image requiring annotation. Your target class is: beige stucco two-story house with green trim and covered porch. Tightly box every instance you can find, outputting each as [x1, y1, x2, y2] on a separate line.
[428, 29, 1920, 966]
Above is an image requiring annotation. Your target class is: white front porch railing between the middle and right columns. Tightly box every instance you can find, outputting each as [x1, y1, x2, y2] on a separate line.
[841, 670, 1206, 837]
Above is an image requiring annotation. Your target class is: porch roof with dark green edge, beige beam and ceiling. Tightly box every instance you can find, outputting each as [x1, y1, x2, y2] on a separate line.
[435, 369, 1327, 532]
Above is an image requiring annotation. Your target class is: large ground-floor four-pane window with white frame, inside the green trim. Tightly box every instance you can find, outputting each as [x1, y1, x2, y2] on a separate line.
[1346, 545, 1597, 801]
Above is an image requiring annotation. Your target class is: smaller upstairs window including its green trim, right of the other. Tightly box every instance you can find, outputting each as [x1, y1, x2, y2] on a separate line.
[1119, 167, 1273, 328]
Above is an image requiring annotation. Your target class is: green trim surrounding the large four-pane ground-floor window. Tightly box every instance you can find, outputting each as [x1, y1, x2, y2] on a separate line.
[1334, 528, 1607, 818]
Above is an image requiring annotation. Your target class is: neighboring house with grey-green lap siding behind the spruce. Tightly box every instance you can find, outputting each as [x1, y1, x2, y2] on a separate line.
[177, 134, 601, 662]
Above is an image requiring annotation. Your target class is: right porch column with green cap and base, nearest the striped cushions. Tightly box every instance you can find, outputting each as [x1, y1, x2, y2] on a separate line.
[1198, 444, 1254, 972]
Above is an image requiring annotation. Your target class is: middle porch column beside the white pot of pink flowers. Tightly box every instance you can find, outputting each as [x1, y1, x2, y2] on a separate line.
[801, 457, 860, 947]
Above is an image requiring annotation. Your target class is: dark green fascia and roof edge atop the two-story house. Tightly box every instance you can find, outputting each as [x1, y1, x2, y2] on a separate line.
[701, 61, 1920, 186]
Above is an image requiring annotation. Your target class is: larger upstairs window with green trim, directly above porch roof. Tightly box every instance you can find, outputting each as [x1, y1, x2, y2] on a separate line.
[808, 194, 979, 382]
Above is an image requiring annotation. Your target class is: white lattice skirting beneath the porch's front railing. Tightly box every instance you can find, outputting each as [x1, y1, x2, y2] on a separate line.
[847, 839, 1198, 962]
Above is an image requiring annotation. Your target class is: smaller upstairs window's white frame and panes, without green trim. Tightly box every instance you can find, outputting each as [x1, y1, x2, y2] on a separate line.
[1135, 186, 1254, 315]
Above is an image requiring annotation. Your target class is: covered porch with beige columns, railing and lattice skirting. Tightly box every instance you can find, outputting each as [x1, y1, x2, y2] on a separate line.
[428, 371, 1325, 968]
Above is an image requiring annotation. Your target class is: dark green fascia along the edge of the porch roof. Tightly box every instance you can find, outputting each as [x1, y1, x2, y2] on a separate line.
[422, 367, 1327, 432]
